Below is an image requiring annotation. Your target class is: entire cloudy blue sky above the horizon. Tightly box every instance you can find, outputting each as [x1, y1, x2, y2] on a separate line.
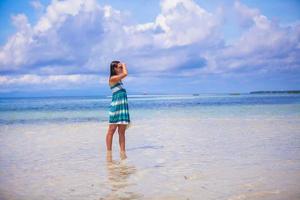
[0, 0, 300, 96]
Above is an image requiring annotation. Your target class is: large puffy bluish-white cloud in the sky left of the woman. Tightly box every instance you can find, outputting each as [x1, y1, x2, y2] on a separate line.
[0, 0, 126, 73]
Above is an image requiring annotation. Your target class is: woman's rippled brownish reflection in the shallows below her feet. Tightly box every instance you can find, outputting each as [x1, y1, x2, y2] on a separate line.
[101, 152, 142, 200]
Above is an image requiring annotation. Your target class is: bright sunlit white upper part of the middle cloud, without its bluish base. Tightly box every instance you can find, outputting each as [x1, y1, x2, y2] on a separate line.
[125, 0, 219, 48]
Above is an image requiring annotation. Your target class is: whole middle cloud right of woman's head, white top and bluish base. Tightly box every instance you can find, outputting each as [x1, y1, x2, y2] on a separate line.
[118, 0, 222, 75]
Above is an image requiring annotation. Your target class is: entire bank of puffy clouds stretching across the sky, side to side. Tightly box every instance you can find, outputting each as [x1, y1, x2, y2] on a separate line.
[0, 0, 300, 90]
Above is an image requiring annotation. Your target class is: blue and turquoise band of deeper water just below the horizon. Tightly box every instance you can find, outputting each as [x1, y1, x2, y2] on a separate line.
[0, 94, 300, 125]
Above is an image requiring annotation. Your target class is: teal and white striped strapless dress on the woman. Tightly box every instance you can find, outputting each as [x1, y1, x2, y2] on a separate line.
[109, 81, 131, 129]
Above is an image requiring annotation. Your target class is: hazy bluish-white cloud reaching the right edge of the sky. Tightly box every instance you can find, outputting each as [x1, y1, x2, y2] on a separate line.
[201, 1, 300, 73]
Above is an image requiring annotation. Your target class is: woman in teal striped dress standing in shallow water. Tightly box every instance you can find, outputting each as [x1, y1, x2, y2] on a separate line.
[106, 61, 130, 159]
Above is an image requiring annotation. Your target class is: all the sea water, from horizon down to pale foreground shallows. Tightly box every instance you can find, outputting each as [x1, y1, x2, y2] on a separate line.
[0, 94, 300, 200]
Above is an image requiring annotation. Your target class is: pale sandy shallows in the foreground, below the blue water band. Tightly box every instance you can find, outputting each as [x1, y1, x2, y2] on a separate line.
[0, 117, 300, 200]
